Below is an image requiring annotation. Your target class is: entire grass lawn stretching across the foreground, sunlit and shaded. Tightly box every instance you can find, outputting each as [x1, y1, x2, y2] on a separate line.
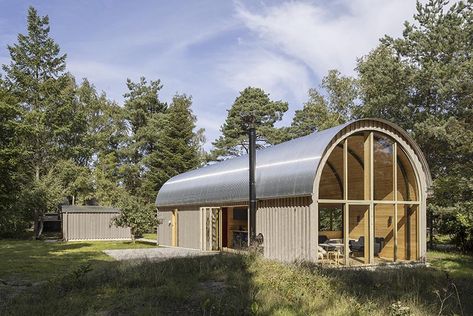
[0, 241, 473, 316]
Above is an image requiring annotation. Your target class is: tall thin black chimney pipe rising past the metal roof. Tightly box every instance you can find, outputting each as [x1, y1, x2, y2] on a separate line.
[248, 126, 256, 245]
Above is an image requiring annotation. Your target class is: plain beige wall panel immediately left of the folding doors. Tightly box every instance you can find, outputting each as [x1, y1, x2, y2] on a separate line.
[177, 208, 200, 249]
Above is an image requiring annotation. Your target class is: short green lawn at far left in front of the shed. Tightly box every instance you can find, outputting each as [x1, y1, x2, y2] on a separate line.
[0, 240, 155, 282]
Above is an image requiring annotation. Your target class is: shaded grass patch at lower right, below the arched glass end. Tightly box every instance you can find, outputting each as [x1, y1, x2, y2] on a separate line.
[302, 266, 473, 315]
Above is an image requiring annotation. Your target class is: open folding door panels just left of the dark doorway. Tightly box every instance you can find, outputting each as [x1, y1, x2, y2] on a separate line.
[200, 207, 222, 251]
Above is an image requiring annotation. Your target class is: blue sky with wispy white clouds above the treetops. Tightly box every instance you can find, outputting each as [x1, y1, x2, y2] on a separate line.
[0, 0, 415, 149]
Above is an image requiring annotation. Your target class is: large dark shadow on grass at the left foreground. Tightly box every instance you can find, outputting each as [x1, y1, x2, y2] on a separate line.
[0, 255, 253, 315]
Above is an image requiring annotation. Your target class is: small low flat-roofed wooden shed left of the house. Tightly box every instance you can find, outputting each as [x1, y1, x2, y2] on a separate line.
[62, 205, 131, 241]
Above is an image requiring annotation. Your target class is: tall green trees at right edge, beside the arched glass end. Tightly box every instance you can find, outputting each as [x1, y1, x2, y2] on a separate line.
[358, 0, 473, 249]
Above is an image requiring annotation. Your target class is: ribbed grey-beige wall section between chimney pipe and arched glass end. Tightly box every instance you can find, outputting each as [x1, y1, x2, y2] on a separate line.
[256, 197, 311, 261]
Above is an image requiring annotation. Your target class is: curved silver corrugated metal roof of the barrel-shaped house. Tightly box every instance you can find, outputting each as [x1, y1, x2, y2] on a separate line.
[156, 119, 430, 206]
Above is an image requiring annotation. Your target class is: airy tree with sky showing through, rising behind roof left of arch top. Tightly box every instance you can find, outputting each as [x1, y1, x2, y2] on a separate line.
[286, 70, 359, 138]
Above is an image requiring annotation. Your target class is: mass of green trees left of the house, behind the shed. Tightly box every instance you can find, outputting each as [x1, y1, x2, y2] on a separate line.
[0, 7, 206, 237]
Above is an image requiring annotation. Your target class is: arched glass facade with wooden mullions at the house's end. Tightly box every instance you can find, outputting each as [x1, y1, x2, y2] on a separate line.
[318, 131, 420, 265]
